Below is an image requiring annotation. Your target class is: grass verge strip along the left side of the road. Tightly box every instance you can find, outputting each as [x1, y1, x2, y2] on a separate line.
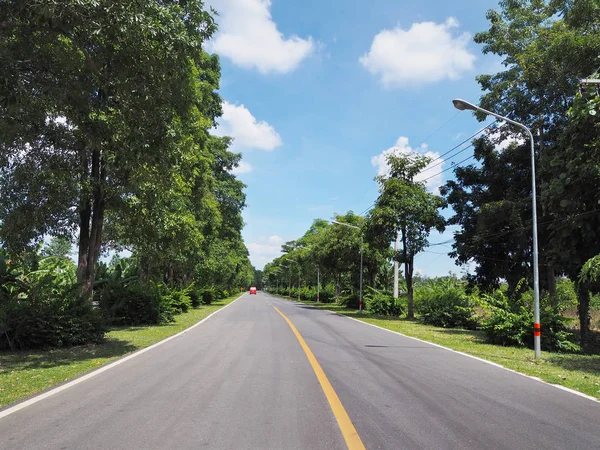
[0, 294, 240, 407]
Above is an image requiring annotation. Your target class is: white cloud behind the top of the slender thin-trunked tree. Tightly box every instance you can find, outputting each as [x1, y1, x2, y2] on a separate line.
[371, 136, 445, 191]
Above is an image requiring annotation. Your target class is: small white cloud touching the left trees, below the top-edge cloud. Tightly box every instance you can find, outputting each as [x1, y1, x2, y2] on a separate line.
[214, 102, 283, 151]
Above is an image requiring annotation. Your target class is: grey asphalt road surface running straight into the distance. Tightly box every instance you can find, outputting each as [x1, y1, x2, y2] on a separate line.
[0, 293, 600, 450]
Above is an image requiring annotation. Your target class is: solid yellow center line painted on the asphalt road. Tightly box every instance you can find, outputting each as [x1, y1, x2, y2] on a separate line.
[273, 306, 365, 450]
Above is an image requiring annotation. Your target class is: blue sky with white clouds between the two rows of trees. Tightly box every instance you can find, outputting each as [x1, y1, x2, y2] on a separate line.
[208, 0, 501, 276]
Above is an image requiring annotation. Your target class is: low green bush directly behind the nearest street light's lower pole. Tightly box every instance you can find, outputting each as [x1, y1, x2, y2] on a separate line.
[481, 291, 579, 352]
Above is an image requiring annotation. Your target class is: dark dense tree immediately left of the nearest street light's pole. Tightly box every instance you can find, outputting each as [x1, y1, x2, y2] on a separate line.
[440, 137, 532, 295]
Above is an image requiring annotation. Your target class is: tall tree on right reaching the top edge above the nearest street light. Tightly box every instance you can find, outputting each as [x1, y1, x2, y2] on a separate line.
[475, 0, 600, 345]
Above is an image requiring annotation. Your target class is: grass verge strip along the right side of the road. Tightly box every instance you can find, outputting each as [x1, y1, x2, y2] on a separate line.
[281, 297, 600, 400]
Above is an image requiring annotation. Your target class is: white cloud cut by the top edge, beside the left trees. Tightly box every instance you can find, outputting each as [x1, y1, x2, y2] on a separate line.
[208, 0, 314, 74]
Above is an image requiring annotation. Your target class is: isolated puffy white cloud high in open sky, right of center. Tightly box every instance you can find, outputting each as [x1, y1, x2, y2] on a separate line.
[360, 17, 475, 88]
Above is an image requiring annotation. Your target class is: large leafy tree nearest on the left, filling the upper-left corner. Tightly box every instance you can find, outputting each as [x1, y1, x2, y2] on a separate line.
[0, 0, 220, 295]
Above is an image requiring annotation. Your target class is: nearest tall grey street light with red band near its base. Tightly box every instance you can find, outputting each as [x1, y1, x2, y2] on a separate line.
[452, 98, 541, 359]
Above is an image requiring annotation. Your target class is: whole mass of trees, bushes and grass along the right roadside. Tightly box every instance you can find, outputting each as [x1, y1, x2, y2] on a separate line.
[263, 0, 600, 397]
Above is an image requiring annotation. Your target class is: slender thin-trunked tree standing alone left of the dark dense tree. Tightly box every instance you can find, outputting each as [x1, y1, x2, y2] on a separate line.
[368, 154, 444, 318]
